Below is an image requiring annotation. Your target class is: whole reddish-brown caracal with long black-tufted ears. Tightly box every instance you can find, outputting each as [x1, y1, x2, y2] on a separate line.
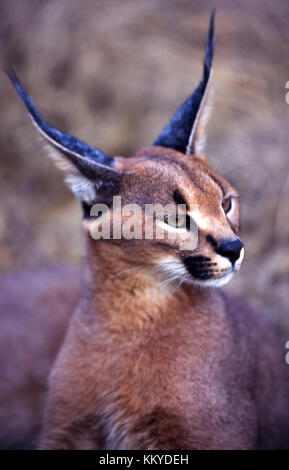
[0, 13, 289, 450]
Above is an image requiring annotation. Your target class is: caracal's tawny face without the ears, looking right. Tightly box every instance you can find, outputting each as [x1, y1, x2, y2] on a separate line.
[85, 146, 244, 286]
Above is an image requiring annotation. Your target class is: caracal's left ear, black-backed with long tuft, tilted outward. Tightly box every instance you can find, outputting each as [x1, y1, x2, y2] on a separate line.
[7, 70, 123, 206]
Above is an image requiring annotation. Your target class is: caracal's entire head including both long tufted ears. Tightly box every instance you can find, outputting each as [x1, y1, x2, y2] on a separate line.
[8, 13, 244, 286]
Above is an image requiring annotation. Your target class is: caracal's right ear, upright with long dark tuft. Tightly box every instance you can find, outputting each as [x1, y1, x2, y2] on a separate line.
[154, 10, 215, 155]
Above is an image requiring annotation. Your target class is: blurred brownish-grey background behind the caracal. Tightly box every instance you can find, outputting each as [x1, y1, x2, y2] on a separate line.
[0, 0, 289, 335]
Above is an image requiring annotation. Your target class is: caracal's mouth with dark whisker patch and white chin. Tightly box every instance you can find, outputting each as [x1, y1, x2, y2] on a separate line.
[183, 256, 234, 287]
